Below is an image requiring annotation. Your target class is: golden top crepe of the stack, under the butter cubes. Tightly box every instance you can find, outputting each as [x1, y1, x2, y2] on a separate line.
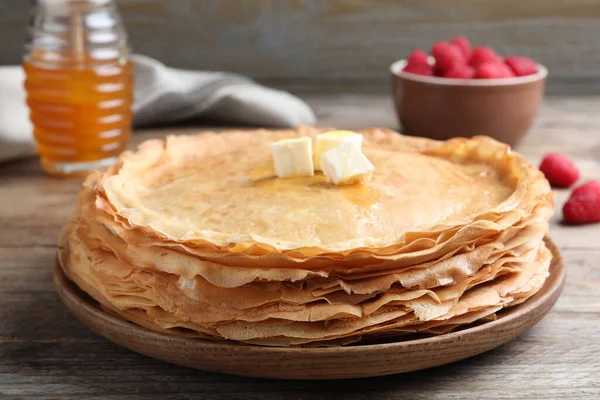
[96, 129, 549, 258]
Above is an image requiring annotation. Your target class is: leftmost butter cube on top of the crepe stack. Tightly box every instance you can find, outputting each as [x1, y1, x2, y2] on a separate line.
[271, 136, 315, 178]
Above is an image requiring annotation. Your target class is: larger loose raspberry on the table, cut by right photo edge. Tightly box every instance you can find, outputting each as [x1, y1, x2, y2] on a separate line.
[563, 181, 600, 224]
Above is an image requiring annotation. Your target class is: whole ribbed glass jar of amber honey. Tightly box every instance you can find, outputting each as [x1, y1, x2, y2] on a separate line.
[23, 0, 133, 176]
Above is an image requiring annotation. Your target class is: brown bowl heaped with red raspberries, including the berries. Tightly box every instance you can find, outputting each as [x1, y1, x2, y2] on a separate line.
[390, 37, 548, 145]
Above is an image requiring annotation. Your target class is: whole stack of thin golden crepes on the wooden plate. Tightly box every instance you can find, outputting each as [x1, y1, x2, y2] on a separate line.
[59, 127, 553, 346]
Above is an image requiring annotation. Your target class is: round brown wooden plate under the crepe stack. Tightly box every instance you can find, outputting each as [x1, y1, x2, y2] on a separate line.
[54, 239, 565, 379]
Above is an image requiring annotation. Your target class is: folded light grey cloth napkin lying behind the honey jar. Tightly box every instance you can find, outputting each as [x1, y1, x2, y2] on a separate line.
[0, 55, 315, 162]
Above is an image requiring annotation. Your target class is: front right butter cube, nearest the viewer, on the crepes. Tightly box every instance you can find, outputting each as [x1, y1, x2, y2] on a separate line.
[321, 142, 374, 185]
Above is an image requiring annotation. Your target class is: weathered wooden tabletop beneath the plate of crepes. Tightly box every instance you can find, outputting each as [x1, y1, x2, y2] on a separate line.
[0, 92, 600, 400]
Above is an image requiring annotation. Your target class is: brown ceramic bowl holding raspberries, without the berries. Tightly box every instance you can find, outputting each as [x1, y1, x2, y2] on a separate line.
[390, 60, 548, 145]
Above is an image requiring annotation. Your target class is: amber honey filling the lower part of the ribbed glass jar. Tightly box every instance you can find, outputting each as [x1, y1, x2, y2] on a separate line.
[23, 57, 133, 173]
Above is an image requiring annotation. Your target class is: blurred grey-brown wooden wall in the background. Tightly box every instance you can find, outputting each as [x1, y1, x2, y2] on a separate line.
[0, 0, 600, 84]
